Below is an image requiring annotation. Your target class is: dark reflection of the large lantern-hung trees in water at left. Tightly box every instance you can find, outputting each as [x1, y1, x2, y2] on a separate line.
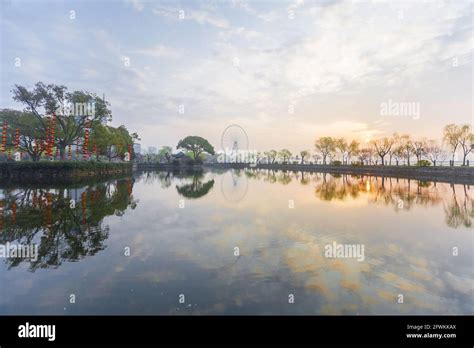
[0, 179, 137, 271]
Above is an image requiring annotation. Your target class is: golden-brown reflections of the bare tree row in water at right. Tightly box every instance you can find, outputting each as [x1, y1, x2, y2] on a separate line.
[246, 169, 474, 228]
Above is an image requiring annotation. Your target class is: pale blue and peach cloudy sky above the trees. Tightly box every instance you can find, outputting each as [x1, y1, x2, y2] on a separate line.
[0, 0, 474, 151]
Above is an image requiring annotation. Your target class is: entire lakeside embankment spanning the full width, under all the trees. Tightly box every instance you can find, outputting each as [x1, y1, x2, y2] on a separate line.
[0, 161, 474, 185]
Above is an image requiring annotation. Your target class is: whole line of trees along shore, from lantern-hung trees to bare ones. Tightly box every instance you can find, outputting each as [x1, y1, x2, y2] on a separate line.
[0, 82, 474, 179]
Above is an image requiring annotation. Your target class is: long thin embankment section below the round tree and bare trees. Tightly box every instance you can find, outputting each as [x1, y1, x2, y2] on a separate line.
[138, 163, 474, 185]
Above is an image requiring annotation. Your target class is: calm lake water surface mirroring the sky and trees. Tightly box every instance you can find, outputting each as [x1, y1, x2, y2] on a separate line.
[0, 170, 474, 315]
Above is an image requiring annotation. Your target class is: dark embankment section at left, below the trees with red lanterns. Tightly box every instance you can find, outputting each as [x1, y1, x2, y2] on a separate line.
[0, 161, 133, 182]
